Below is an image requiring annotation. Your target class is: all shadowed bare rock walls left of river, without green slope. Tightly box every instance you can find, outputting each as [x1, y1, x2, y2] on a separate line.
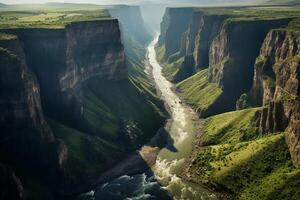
[0, 19, 127, 199]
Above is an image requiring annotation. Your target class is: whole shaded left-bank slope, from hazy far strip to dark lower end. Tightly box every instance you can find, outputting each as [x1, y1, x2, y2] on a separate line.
[44, 16, 166, 182]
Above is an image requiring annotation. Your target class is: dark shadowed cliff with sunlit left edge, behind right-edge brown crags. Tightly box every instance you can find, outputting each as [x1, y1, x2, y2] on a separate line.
[208, 19, 289, 107]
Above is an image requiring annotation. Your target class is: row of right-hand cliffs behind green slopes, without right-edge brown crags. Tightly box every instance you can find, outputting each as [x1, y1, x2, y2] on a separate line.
[158, 8, 291, 116]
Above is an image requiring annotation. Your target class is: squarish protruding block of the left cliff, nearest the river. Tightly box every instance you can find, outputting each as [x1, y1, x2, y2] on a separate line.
[60, 20, 126, 91]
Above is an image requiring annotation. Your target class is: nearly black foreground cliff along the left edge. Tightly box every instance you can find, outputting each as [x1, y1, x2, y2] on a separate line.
[0, 35, 67, 196]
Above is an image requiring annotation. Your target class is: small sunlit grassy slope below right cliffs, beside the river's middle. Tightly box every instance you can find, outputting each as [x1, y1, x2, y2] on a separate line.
[176, 69, 222, 110]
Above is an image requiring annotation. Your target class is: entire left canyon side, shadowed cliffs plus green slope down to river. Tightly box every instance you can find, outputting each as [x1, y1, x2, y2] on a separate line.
[0, 7, 165, 199]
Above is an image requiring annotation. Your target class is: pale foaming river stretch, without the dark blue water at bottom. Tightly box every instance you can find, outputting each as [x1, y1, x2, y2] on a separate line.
[148, 37, 216, 199]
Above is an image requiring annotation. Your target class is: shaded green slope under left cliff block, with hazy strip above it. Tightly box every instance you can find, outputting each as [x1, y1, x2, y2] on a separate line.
[75, 27, 166, 149]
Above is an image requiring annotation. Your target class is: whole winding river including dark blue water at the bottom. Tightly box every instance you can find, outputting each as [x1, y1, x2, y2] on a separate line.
[81, 38, 217, 200]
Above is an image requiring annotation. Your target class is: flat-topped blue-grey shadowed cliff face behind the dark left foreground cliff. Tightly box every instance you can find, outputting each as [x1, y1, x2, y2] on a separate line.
[7, 20, 127, 121]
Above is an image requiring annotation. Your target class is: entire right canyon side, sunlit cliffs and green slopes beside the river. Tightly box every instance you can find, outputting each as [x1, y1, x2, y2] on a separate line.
[166, 5, 300, 200]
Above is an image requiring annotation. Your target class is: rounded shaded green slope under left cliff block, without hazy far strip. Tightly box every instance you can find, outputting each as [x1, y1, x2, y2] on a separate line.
[84, 78, 163, 144]
